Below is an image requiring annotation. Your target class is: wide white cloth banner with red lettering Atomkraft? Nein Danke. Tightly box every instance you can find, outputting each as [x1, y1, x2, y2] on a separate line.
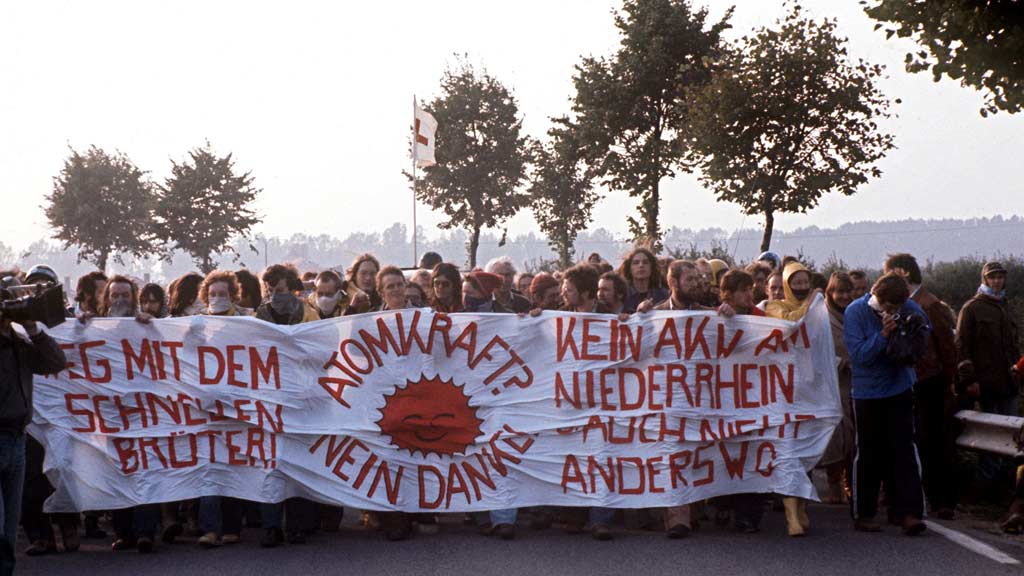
[30, 296, 841, 511]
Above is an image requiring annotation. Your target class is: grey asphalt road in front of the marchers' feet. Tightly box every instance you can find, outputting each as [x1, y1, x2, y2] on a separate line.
[16, 505, 1024, 576]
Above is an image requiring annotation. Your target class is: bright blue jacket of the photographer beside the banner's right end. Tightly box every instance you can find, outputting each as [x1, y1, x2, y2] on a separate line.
[843, 293, 928, 400]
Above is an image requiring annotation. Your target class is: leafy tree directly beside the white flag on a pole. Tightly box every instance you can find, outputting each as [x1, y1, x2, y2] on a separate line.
[416, 60, 529, 266]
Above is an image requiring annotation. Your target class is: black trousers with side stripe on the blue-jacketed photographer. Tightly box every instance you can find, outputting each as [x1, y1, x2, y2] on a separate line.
[850, 389, 925, 520]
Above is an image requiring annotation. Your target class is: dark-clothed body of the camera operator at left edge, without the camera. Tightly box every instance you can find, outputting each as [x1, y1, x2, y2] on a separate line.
[0, 276, 68, 576]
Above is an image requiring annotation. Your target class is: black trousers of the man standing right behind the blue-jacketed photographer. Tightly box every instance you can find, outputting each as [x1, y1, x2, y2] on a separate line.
[913, 376, 957, 510]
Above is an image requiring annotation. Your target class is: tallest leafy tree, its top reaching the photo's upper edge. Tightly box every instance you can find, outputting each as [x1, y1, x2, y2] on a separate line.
[572, 0, 732, 246]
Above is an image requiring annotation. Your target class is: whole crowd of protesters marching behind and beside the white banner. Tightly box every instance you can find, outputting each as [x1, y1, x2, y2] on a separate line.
[0, 247, 1024, 562]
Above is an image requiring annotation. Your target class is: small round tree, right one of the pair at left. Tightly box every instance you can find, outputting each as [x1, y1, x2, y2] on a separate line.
[157, 142, 262, 274]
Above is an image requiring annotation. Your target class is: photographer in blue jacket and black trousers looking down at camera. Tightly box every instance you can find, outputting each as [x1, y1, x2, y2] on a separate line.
[843, 273, 931, 536]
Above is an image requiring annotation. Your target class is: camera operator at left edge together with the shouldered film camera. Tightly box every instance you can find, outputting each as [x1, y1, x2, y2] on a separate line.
[0, 270, 68, 576]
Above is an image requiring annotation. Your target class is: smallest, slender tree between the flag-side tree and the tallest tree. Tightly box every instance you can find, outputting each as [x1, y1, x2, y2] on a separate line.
[529, 121, 600, 269]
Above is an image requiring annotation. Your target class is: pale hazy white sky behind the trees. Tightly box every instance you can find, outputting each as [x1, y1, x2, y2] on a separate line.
[0, 0, 1024, 248]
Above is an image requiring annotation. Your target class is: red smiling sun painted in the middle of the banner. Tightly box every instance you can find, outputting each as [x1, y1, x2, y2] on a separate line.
[377, 376, 483, 456]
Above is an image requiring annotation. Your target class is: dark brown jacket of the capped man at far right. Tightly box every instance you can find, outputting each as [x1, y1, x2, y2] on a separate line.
[956, 294, 1020, 397]
